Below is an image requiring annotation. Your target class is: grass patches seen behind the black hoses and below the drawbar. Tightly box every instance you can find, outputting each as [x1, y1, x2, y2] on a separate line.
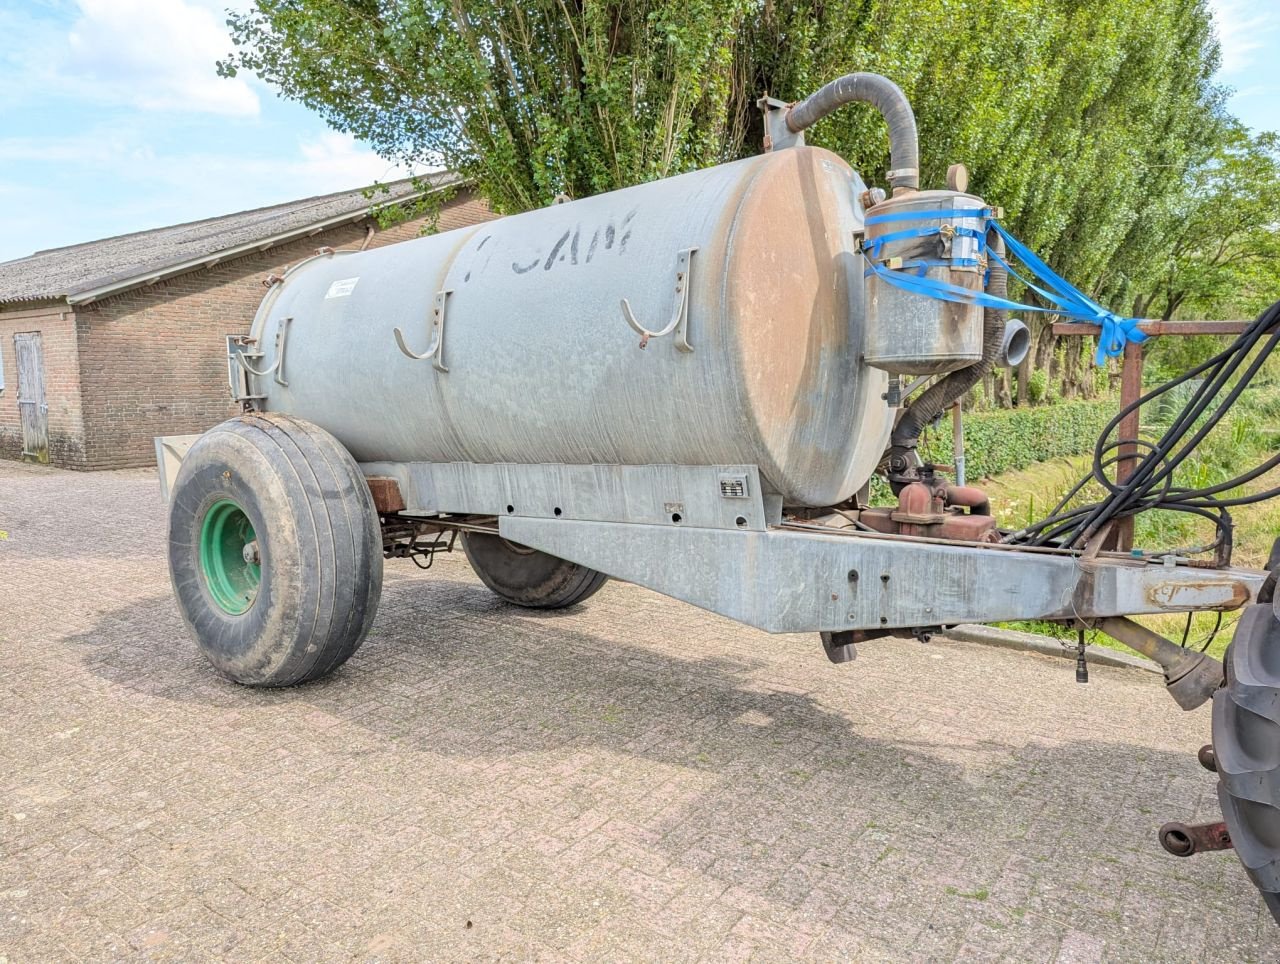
[982, 385, 1280, 657]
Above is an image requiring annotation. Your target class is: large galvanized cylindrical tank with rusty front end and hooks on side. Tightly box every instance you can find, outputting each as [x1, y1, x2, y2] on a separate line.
[252, 147, 891, 506]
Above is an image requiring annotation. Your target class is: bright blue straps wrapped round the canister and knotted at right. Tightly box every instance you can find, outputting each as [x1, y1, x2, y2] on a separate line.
[864, 207, 1149, 365]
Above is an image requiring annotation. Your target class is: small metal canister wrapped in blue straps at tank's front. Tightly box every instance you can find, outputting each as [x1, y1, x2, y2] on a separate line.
[867, 191, 986, 375]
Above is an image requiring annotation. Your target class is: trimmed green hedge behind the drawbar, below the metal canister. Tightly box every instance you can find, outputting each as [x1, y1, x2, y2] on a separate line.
[920, 398, 1120, 479]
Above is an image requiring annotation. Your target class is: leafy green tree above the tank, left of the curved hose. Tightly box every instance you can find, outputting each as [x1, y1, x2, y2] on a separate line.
[219, 0, 754, 213]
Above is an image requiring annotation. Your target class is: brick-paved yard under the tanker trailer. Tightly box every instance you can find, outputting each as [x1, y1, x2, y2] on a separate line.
[0, 463, 1280, 963]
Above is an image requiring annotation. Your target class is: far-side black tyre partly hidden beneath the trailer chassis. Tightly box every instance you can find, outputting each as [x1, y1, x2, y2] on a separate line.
[462, 533, 609, 609]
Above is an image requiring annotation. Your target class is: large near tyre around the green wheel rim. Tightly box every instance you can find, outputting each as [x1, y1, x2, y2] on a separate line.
[169, 414, 383, 686]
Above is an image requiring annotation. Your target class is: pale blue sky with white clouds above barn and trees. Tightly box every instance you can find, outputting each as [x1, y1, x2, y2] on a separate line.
[0, 0, 1280, 261]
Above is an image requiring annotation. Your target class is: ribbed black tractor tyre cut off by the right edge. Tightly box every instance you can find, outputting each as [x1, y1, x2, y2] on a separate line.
[1213, 542, 1280, 923]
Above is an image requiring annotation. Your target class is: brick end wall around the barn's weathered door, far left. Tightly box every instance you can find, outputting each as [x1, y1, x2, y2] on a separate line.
[0, 305, 84, 466]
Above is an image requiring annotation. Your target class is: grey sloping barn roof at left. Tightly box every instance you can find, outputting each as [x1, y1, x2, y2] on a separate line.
[0, 173, 458, 303]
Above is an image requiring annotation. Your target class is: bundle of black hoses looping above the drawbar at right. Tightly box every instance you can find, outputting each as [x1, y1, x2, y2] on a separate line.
[1005, 301, 1280, 558]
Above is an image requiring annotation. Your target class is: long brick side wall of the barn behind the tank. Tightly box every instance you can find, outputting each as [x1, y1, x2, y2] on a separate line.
[62, 195, 492, 469]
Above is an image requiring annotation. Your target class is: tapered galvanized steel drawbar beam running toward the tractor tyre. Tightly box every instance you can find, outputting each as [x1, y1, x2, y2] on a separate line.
[498, 516, 1266, 632]
